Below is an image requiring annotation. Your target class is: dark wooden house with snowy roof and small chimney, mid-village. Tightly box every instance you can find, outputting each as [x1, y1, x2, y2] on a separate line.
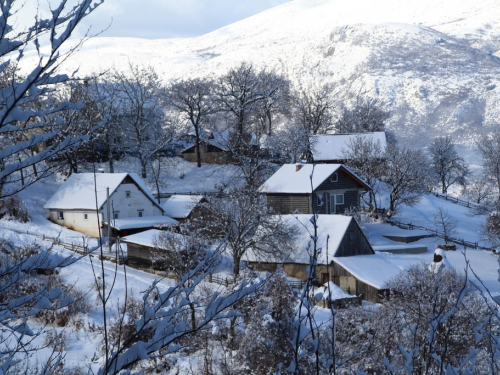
[259, 164, 370, 214]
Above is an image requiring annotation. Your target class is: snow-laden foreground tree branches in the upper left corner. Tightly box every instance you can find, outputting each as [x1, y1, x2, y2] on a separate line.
[0, 0, 101, 197]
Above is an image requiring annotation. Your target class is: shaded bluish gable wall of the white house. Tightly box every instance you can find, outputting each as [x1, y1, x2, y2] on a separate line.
[106, 181, 163, 221]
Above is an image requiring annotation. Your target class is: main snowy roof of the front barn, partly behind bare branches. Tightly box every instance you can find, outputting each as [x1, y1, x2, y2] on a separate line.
[247, 214, 360, 264]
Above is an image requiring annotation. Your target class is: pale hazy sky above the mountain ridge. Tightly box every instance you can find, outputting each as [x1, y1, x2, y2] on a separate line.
[22, 0, 291, 39]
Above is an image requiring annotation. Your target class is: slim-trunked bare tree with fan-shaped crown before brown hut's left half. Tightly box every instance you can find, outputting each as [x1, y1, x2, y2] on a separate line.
[167, 78, 217, 168]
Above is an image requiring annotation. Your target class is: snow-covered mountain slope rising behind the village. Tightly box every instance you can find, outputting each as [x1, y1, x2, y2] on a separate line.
[29, 0, 500, 150]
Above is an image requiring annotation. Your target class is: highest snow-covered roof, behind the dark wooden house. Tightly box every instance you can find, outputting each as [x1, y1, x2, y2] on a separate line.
[311, 132, 387, 161]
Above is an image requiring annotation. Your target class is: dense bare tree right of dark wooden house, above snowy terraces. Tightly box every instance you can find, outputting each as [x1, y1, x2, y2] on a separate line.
[383, 147, 429, 216]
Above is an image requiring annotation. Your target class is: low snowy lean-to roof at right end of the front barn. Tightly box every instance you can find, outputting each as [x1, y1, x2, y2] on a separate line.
[334, 254, 402, 289]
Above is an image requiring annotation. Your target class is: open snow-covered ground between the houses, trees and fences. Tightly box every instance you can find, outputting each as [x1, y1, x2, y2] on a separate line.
[0, 160, 500, 369]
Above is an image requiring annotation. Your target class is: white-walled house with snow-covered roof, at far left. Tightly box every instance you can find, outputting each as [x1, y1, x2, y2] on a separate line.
[44, 173, 163, 237]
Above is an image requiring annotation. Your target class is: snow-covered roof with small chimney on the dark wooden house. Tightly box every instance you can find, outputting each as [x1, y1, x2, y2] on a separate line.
[259, 164, 368, 194]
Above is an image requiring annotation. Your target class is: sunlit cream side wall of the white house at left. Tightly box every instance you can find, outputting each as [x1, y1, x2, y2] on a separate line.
[49, 210, 102, 237]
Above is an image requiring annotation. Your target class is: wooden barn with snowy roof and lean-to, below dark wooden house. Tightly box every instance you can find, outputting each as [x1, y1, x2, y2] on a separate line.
[246, 215, 401, 302]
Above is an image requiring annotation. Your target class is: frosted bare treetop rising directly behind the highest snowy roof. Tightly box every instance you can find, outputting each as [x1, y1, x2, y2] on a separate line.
[335, 99, 390, 133]
